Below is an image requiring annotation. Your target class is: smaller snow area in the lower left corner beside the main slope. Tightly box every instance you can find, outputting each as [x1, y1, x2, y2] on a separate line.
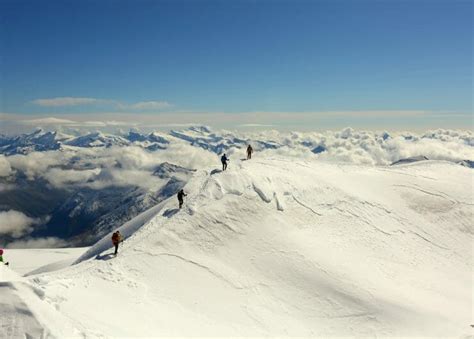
[0, 248, 91, 339]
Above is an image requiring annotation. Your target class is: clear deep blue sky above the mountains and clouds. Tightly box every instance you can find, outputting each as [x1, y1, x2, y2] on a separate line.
[0, 0, 472, 128]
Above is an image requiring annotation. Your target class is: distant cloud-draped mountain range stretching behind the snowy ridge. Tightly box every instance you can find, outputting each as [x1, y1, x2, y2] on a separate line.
[0, 126, 474, 246]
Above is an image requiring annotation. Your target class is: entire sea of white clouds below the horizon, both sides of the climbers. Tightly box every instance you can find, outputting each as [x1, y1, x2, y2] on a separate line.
[0, 128, 474, 247]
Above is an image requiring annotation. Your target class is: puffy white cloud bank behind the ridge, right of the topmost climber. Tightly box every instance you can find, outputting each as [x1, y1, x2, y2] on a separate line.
[223, 128, 474, 166]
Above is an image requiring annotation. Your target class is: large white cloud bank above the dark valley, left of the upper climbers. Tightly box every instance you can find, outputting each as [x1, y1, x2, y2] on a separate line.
[0, 140, 218, 189]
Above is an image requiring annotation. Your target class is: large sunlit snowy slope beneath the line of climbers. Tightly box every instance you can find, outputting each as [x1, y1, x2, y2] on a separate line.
[23, 158, 473, 337]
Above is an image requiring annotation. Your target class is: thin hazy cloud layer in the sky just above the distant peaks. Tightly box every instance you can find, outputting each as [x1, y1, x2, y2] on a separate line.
[0, 110, 473, 134]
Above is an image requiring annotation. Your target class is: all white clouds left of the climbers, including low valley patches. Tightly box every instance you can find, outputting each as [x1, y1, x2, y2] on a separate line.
[0, 139, 216, 248]
